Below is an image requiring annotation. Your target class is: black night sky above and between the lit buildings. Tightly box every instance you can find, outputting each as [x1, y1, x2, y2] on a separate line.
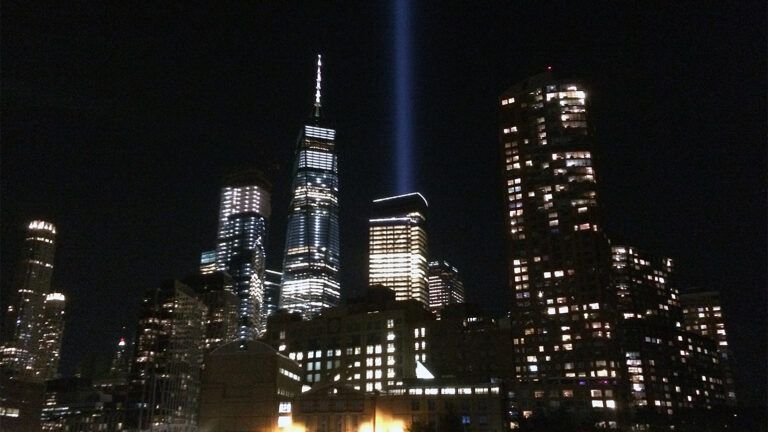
[0, 1, 768, 405]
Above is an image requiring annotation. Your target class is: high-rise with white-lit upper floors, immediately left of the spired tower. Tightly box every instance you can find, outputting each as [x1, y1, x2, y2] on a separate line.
[216, 170, 272, 339]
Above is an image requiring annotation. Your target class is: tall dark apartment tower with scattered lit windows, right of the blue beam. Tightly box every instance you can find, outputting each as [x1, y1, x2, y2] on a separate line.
[499, 73, 620, 426]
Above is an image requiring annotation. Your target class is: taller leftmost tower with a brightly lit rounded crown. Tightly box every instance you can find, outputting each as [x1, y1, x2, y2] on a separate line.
[0, 220, 59, 380]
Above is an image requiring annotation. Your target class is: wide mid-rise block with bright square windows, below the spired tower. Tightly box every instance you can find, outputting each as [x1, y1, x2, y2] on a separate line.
[263, 287, 434, 392]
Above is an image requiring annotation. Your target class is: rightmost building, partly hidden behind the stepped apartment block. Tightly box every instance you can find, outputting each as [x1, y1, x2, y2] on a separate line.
[680, 290, 736, 405]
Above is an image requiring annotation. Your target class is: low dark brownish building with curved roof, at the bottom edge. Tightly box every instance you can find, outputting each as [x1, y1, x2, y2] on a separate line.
[199, 341, 302, 432]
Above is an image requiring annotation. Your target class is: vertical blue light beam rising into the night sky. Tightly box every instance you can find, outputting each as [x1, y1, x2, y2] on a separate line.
[395, 0, 413, 194]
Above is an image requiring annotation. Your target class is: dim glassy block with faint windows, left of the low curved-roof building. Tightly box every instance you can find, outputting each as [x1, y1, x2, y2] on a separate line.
[126, 280, 207, 431]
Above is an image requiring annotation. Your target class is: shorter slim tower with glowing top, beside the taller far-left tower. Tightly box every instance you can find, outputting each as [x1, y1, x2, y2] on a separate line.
[35, 292, 66, 381]
